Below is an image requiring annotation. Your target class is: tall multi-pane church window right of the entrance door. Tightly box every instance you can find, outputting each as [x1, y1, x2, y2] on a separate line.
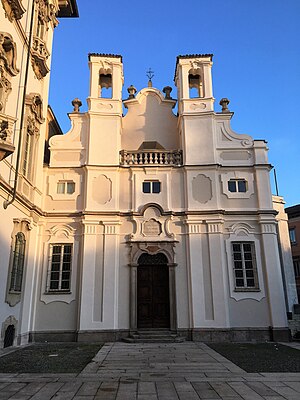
[231, 242, 258, 290]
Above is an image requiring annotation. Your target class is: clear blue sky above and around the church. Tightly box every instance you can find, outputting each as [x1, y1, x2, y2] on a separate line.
[49, 0, 300, 206]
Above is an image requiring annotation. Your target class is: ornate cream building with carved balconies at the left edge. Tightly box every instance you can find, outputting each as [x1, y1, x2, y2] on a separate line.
[0, 0, 78, 346]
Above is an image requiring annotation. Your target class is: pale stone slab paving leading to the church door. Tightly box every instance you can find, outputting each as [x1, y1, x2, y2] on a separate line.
[0, 342, 300, 400]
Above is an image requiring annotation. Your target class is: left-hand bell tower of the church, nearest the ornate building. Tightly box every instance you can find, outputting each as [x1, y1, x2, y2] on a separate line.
[87, 53, 124, 165]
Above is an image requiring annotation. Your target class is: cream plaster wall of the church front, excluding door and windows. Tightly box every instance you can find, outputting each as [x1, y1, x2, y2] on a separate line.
[36, 54, 287, 340]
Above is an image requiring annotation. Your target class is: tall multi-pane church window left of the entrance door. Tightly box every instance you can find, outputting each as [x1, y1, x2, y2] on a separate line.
[47, 244, 73, 292]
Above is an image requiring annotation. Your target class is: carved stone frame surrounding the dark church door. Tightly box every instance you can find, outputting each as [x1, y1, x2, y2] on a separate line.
[129, 241, 177, 332]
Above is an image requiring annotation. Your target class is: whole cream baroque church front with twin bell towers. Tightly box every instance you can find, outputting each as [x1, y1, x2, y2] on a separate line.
[1, 48, 294, 342]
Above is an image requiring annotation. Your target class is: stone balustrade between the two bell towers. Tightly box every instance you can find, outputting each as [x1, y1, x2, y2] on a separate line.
[120, 150, 182, 167]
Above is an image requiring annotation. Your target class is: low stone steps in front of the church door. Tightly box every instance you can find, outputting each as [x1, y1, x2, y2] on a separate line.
[123, 329, 185, 343]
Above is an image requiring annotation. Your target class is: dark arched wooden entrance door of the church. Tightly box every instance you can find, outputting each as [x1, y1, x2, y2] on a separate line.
[137, 253, 170, 329]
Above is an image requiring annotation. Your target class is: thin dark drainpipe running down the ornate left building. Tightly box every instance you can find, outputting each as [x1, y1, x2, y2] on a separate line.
[3, 0, 35, 210]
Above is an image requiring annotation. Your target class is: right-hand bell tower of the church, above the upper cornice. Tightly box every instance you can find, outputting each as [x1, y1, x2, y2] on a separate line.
[174, 54, 215, 165]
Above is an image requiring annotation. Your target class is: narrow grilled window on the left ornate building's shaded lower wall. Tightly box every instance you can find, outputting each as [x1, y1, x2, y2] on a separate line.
[9, 232, 26, 292]
